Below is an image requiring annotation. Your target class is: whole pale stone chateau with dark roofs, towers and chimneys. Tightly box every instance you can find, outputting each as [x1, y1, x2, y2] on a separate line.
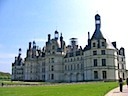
[12, 14, 127, 82]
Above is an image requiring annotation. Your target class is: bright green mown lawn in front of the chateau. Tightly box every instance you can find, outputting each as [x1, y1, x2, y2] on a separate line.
[0, 82, 118, 96]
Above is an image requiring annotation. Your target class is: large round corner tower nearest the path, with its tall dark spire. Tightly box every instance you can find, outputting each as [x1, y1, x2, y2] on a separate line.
[84, 14, 118, 81]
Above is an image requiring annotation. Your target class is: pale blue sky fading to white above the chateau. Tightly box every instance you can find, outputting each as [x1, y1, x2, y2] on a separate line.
[0, 0, 128, 73]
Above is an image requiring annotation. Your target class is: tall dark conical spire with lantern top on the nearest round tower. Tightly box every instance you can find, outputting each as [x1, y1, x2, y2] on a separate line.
[91, 14, 104, 40]
